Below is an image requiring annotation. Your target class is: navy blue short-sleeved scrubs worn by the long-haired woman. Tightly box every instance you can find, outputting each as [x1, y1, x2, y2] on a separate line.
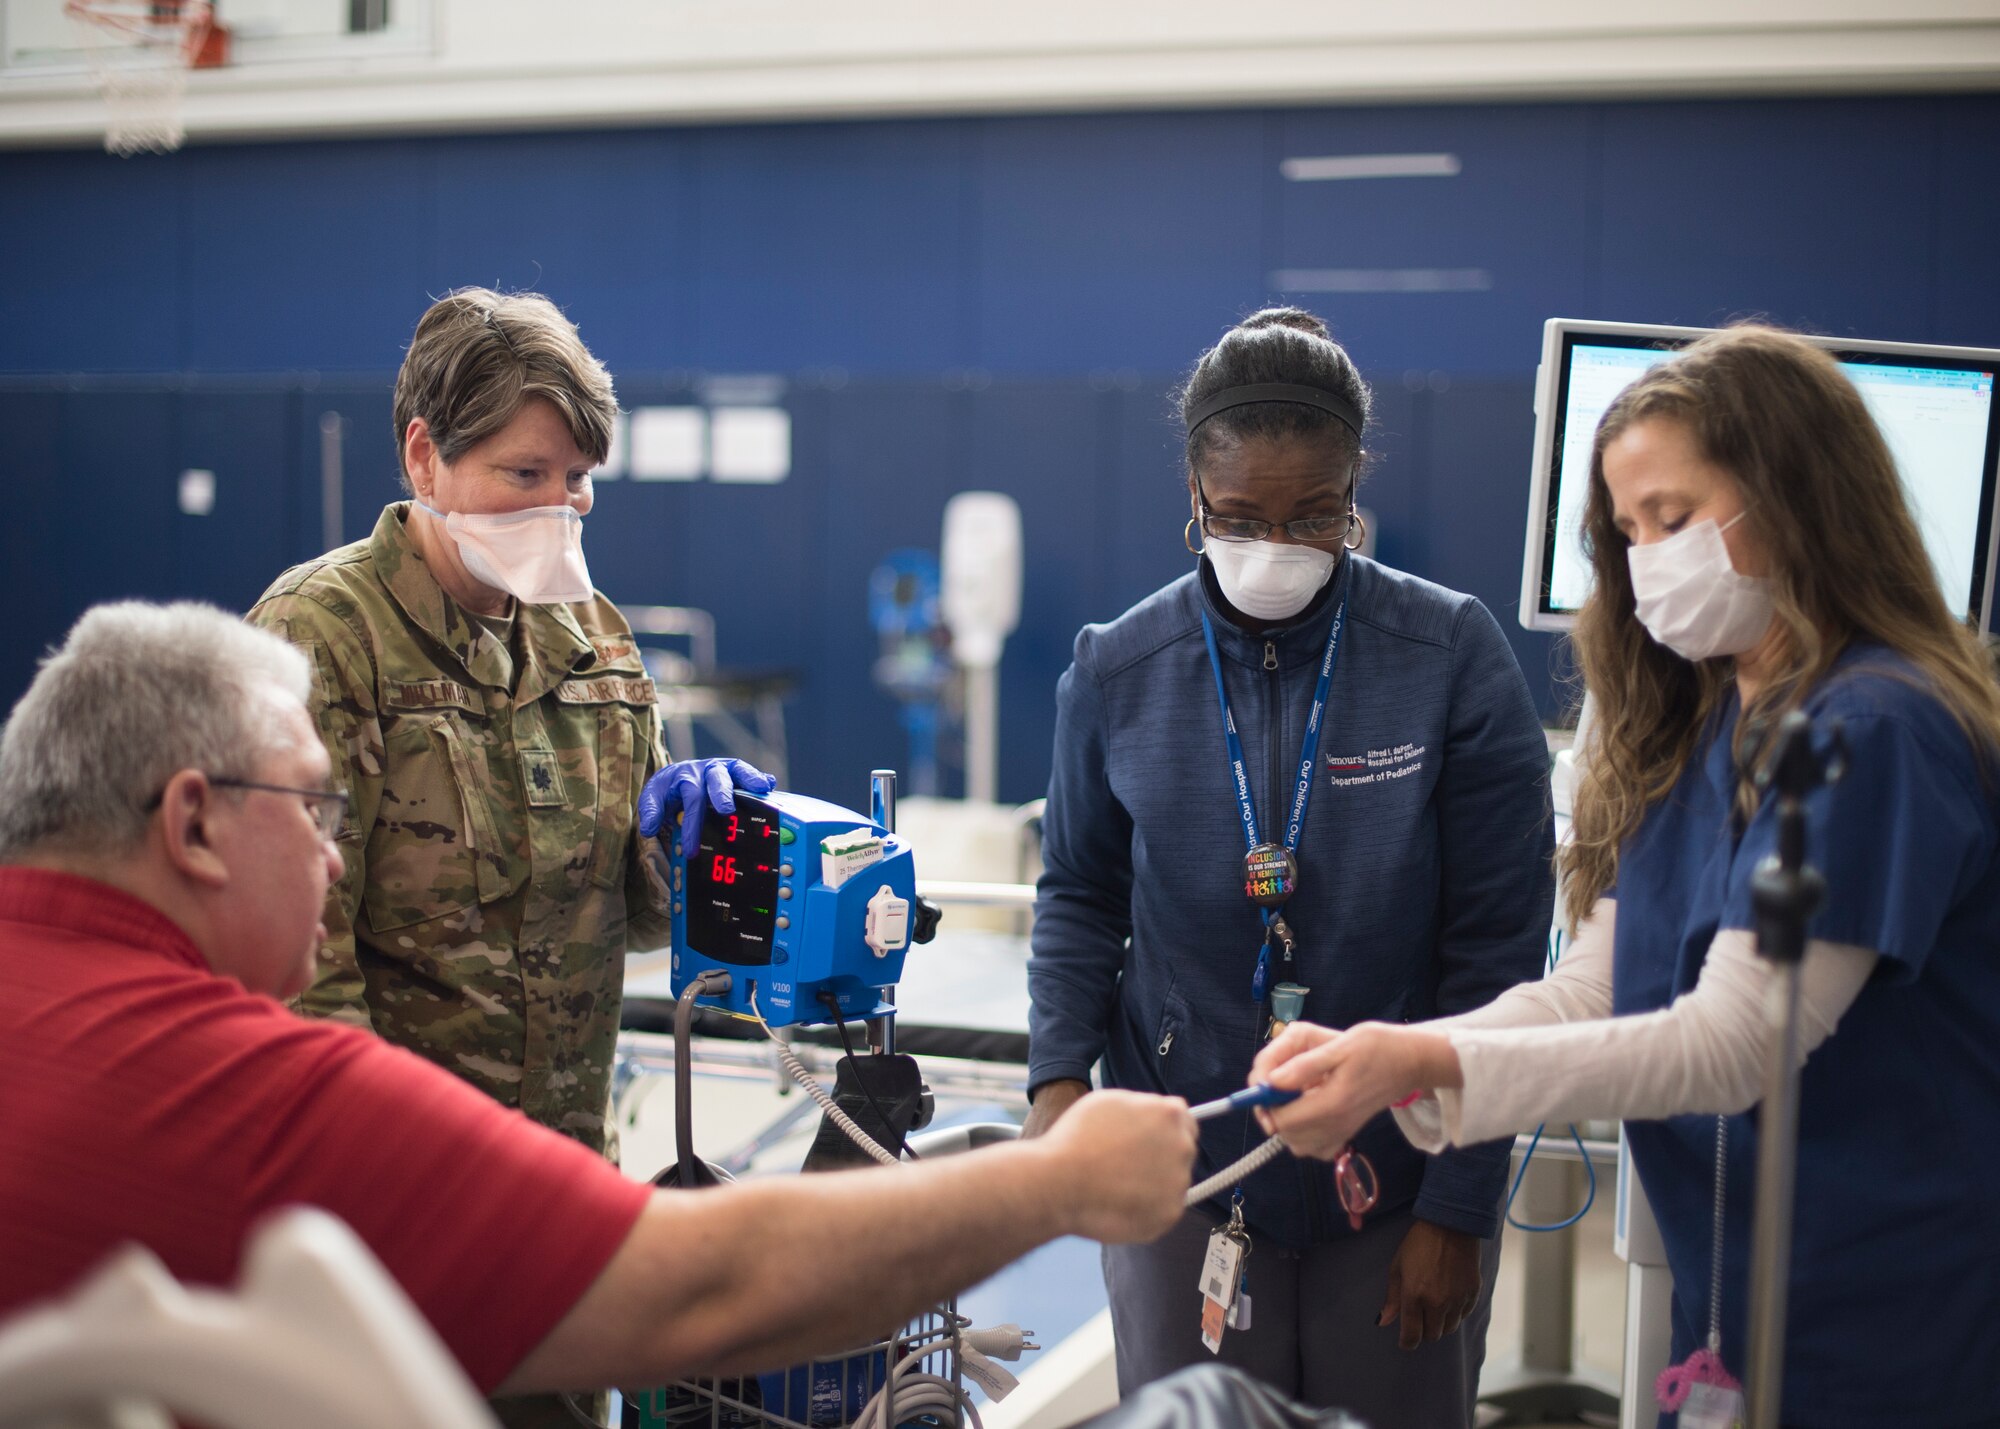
[1614, 646, 2000, 1429]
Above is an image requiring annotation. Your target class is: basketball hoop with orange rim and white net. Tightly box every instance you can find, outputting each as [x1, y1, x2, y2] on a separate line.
[62, 0, 226, 158]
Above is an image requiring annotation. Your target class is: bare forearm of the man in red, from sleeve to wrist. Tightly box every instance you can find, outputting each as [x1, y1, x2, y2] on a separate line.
[506, 1143, 1076, 1391]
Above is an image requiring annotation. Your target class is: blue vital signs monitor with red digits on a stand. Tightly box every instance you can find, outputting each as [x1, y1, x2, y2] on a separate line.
[662, 791, 934, 1027]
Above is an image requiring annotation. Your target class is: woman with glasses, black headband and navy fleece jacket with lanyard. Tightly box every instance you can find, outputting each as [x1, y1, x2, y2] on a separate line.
[1028, 308, 1554, 1427]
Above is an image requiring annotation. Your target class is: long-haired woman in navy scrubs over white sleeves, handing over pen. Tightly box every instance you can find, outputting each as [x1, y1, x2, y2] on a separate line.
[1252, 326, 2000, 1425]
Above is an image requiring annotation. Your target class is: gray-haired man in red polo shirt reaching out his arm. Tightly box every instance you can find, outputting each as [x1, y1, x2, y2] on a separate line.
[0, 602, 1194, 1391]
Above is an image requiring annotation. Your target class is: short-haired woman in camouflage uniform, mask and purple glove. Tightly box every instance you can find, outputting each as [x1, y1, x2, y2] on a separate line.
[250, 288, 770, 1425]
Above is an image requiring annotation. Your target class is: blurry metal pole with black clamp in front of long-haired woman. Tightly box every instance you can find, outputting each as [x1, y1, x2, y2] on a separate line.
[1746, 710, 1842, 1429]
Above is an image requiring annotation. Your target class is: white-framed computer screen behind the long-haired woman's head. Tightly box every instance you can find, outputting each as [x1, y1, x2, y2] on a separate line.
[1520, 318, 2000, 630]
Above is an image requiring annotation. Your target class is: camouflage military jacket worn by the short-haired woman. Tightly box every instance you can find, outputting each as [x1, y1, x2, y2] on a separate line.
[250, 502, 668, 1151]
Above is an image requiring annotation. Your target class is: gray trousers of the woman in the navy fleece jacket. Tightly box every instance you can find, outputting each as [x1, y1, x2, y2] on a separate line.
[1104, 1211, 1500, 1429]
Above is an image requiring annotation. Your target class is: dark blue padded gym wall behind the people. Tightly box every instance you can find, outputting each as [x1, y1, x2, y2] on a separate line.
[0, 96, 2000, 799]
